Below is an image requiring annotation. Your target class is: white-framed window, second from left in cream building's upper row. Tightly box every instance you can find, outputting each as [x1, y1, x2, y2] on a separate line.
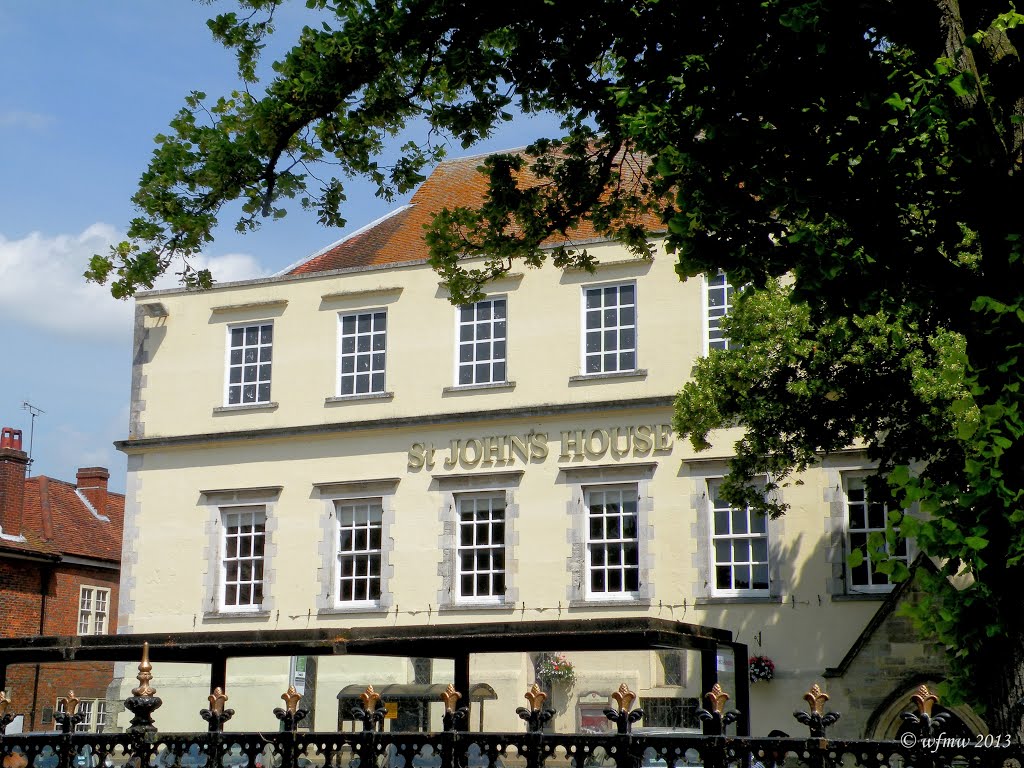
[338, 309, 387, 397]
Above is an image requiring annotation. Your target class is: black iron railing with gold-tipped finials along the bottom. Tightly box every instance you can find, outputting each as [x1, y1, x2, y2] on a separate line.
[0, 649, 1024, 768]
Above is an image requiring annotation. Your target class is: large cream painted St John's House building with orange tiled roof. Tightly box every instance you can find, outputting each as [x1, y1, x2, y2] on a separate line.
[120, 154, 954, 735]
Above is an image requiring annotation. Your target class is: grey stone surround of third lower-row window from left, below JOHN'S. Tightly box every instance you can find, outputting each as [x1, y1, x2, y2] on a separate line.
[433, 470, 525, 611]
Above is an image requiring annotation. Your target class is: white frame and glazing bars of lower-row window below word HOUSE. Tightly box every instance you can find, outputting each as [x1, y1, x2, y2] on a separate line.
[583, 482, 643, 602]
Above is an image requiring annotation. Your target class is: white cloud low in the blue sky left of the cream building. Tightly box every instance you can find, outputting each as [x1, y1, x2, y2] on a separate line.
[0, 223, 269, 340]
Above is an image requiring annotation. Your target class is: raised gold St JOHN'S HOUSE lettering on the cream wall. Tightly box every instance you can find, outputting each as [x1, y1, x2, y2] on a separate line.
[409, 424, 673, 470]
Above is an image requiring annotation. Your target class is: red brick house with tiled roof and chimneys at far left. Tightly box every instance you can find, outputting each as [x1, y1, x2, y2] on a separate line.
[0, 427, 124, 732]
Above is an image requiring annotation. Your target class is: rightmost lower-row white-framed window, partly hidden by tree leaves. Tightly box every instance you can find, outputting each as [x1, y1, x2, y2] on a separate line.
[843, 474, 910, 593]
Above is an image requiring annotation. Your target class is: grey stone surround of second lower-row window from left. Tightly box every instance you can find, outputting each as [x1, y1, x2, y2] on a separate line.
[313, 477, 400, 615]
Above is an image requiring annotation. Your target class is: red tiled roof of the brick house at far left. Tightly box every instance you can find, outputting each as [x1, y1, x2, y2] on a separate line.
[0, 476, 125, 562]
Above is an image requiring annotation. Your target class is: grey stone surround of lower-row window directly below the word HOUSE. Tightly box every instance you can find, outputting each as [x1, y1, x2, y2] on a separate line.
[558, 462, 658, 607]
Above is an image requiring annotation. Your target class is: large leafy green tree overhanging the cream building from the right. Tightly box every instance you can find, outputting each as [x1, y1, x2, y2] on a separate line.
[96, 0, 1024, 734]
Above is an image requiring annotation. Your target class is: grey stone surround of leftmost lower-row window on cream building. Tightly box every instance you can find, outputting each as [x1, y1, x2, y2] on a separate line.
[200, 485, 282, 621]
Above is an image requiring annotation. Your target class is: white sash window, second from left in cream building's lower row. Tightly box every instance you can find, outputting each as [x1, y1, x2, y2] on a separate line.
[335, 499, 384, 606]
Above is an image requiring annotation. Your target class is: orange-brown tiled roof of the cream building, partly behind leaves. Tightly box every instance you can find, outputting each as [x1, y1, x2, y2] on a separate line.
[288, 150, 665, 274]
